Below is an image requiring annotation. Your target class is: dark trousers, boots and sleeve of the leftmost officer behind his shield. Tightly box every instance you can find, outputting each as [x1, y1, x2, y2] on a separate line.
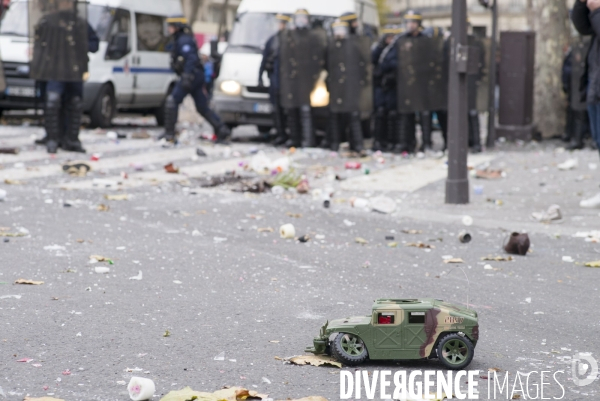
[36, 24, 100, 153]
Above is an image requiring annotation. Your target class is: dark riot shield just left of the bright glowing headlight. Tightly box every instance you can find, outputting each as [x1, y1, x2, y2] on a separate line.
[279, 29, 327, 109]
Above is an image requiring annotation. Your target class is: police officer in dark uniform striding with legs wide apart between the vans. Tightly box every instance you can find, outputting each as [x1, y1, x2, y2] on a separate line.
[159, 15, 231, 143]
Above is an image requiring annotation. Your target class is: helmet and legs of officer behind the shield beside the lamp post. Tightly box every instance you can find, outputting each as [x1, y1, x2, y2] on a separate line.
[395, 10, 432, 153]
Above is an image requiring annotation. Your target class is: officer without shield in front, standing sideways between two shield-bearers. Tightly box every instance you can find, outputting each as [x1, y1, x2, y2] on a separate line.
[371, 28, 400, 151]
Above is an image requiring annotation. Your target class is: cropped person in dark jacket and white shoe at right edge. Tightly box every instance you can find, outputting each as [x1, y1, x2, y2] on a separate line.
[571, 0, 600, 208]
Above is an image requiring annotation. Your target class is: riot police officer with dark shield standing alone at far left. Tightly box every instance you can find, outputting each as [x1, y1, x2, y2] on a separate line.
[30, 0, 99, 153]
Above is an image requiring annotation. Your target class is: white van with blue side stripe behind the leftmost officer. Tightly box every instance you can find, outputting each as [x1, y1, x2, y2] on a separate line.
[0, 0, 182, 127]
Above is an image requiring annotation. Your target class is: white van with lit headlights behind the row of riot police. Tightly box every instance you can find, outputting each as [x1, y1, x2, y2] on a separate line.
[213, 0, 379, 132]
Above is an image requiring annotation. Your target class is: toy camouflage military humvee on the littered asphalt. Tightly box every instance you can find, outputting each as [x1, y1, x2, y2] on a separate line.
[306, 298, 479, 370]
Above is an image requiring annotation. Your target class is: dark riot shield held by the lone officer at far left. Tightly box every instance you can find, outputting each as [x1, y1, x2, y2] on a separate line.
[29, 0, 88, 82]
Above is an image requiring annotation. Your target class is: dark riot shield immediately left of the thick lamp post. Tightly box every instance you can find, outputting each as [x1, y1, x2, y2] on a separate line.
[396, 36, 448, 113]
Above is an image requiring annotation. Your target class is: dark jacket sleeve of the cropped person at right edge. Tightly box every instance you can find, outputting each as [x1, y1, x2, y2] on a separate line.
[571, 0, 600, 103]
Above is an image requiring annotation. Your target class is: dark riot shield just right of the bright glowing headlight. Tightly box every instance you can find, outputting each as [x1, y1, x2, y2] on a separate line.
[327, 35, 373, 113]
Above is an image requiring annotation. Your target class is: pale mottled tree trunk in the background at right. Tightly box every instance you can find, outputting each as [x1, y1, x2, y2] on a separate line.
[534, 0, 571, 138]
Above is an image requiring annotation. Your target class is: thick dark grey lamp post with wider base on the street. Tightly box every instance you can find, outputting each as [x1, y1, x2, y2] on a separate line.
[446, 0, 469, 204]
